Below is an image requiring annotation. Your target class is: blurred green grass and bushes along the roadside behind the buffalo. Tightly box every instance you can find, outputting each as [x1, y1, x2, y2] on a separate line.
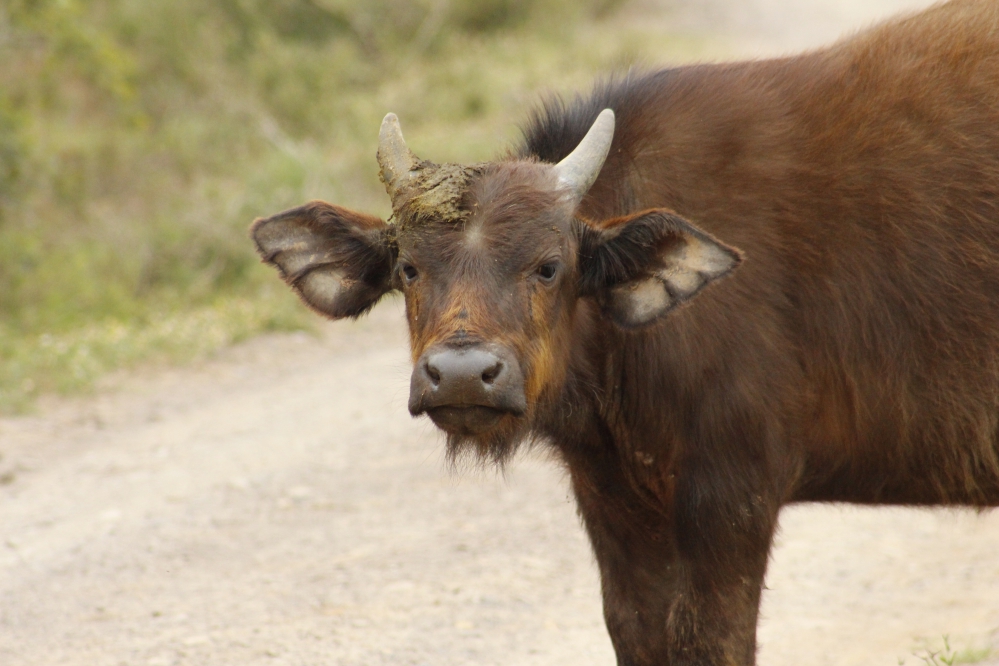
[0, 0, 720, 411]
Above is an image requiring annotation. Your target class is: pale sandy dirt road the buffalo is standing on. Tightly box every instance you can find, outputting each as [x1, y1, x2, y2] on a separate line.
[0, 0, 999, 666]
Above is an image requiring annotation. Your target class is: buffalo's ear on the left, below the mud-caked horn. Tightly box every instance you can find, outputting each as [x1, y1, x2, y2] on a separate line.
[250, 201, 395, 319]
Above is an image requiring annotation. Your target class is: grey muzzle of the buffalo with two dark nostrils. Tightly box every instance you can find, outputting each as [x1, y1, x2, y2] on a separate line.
[409, 346, 526, 415]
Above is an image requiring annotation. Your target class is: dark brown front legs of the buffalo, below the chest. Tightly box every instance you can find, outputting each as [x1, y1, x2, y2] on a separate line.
[573, 467, 776, 666]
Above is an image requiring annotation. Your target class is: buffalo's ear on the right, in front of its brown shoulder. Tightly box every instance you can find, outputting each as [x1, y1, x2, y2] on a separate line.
[580, 209, 742, 328]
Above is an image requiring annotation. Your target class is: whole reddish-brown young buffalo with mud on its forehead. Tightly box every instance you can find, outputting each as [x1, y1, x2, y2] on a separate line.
[253, 0, 999, 665]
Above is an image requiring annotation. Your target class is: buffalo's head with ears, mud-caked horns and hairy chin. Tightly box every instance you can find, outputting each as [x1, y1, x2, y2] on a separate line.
[251, 109, 739, 459]
